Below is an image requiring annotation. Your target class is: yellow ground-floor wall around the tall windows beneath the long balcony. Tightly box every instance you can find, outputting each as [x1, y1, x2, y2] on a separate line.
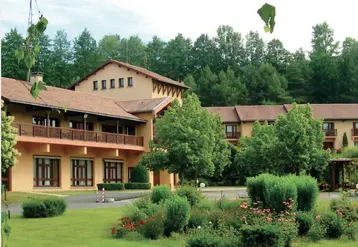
[11, 142, 141, 191]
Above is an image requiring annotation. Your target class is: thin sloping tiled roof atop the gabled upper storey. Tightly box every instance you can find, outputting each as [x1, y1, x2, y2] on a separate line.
[69, 59, 190, 88]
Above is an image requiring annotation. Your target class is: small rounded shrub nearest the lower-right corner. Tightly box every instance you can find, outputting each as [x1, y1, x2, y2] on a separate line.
[321, 212, 344, 238]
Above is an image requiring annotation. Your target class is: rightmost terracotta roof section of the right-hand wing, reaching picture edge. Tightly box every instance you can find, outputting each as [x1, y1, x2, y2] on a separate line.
[284, 104, 358, 120]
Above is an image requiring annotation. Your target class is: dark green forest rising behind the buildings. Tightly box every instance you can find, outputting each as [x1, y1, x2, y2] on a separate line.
[1, 22, 358, 106]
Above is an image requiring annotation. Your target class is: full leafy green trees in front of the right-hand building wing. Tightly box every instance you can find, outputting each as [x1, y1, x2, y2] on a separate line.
[235, 104, 329, 176]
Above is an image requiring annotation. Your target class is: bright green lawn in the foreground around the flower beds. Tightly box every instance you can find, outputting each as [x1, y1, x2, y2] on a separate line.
[9, 201, 358, 247]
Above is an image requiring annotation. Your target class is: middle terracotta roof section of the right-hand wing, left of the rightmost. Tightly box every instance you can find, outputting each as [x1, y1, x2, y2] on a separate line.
[235, 105, 287, 122]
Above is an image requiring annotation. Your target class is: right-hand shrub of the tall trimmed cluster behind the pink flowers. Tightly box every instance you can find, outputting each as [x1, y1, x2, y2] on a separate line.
[288, 176, 319, 211]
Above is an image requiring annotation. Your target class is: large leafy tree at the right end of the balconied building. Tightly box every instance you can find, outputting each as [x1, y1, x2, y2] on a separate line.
[140, 94, 230, 181]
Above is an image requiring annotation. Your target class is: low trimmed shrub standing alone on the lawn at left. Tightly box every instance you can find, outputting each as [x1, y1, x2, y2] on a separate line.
[22, 198, 67, 218]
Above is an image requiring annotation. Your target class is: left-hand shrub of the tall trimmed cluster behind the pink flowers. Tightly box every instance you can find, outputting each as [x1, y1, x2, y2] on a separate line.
[246, 174, 277, 202]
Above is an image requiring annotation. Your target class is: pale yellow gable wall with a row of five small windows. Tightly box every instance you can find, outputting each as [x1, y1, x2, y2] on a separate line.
[75, 64, 153, 100]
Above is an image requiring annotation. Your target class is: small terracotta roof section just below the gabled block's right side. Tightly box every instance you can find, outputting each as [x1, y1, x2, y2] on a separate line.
[116, 97, 172, 113]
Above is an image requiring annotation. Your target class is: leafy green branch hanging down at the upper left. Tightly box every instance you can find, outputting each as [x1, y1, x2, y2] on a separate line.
[15, 15, 48, 99]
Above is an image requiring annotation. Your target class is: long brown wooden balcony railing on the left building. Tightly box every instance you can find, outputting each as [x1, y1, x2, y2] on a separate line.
[13, 123, 144, 147]
